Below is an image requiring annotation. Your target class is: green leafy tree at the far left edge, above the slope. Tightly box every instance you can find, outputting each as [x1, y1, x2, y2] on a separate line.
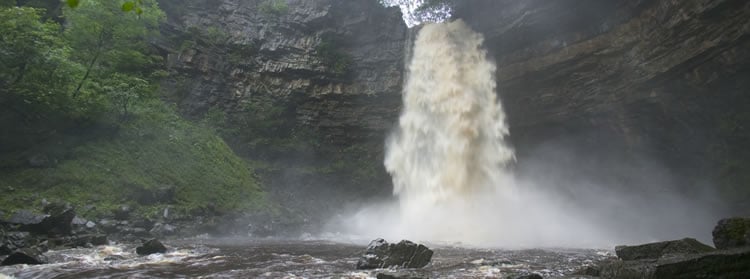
[0, 7, 86, 118]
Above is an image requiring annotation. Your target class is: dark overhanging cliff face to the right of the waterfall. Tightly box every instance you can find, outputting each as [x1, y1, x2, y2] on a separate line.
[456, 0, 750, 210]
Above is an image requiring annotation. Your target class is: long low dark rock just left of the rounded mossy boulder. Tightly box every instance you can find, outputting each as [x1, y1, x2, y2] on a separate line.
[615, 238, 715, 261]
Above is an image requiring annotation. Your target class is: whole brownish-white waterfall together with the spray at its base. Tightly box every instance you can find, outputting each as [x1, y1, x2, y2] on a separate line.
[329, 21, 728, 248]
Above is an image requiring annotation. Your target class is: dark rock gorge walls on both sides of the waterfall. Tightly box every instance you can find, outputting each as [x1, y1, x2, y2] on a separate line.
[157, 0, 750, 225]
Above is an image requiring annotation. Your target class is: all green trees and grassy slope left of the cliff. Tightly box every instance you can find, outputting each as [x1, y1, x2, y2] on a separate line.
[0, 0, 268, 216]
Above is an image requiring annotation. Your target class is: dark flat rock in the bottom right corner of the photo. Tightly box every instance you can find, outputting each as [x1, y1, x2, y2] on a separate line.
[653, 248, 750, 278]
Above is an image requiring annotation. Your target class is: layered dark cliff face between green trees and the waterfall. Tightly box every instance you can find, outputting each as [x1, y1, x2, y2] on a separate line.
[158, 0, 408, 224]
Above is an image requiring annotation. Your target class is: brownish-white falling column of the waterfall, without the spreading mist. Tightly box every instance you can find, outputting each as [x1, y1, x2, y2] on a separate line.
[385, 20, 514, 243]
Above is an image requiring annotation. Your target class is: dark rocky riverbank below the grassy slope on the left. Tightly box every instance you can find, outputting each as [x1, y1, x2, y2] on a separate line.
[0, 201, 300, 265]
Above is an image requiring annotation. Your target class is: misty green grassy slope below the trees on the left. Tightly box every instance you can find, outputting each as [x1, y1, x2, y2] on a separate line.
[0, 101, 269, 221]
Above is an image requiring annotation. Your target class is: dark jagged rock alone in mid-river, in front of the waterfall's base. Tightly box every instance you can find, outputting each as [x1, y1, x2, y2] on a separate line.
[357, 238, 433, 269]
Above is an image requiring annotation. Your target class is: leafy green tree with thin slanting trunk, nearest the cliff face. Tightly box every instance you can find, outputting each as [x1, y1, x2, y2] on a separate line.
[64, 0, 165, 96]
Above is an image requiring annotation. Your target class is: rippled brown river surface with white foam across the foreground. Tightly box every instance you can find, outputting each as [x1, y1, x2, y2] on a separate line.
[0, 239, 611, 278]
